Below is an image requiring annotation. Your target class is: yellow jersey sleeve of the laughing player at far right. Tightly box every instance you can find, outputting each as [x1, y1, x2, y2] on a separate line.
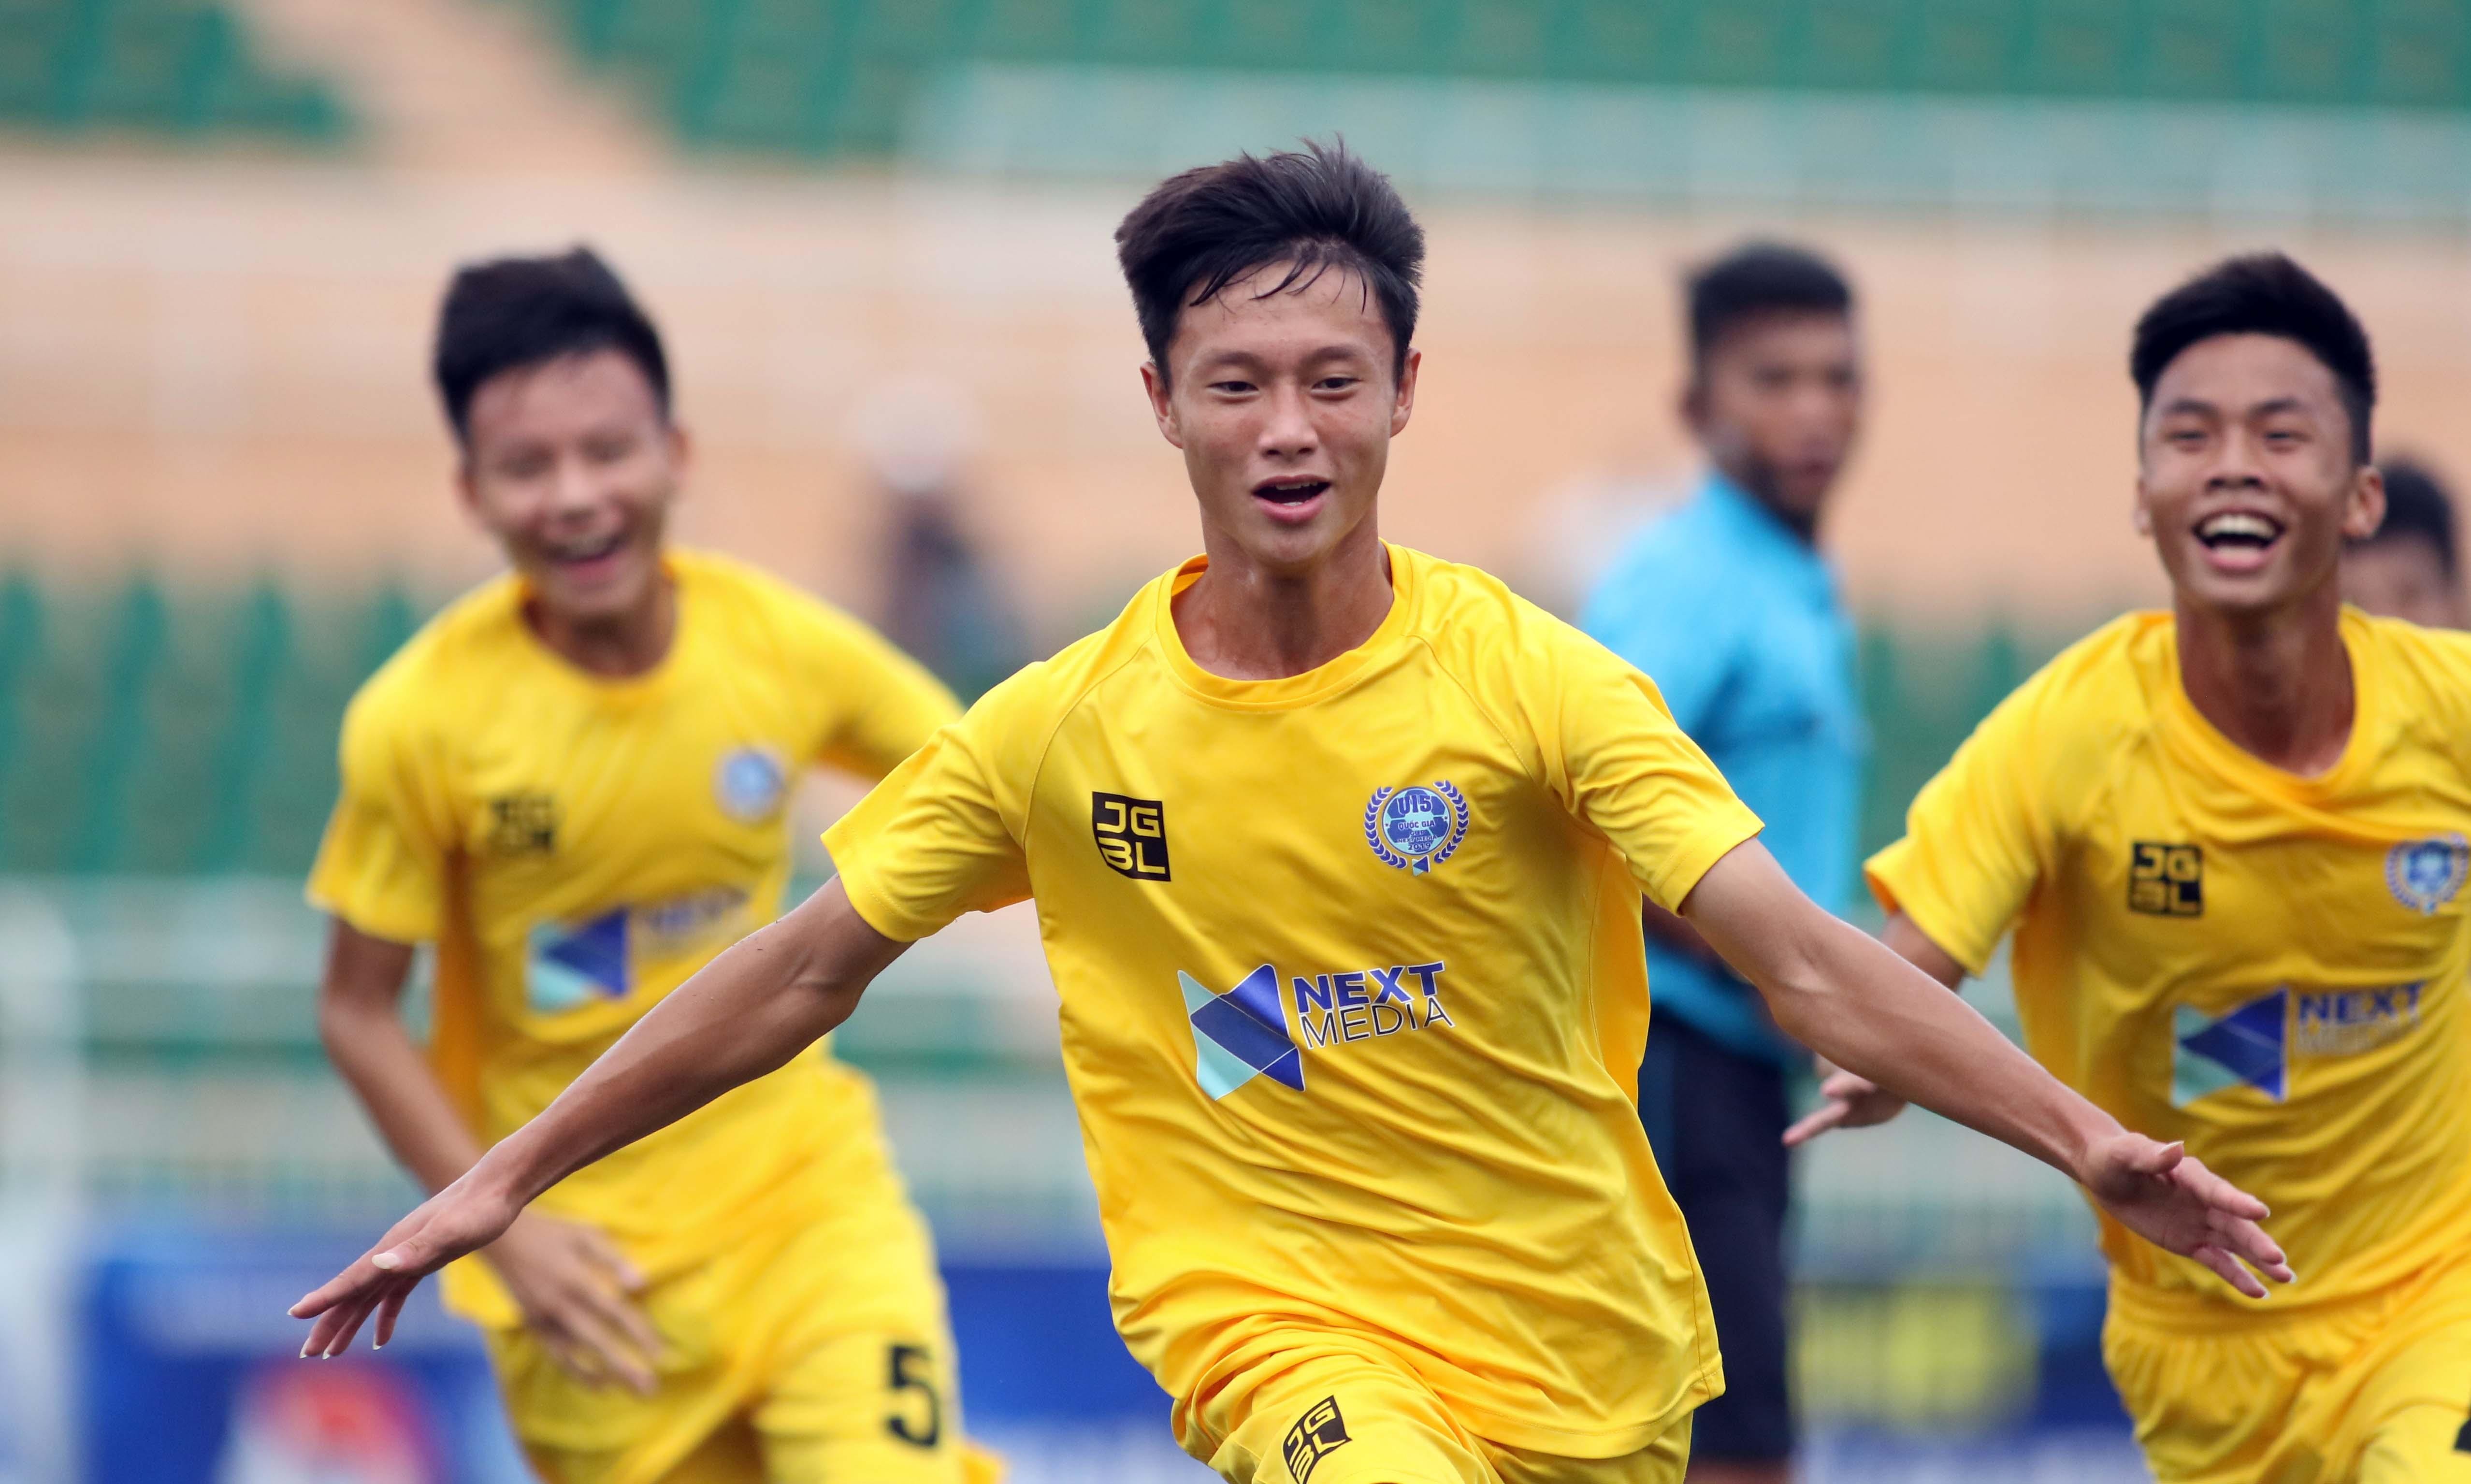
[1863, 684, 2051, 975]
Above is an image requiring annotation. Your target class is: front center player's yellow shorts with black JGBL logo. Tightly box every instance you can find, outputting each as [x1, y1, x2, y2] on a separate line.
[1186, 1348, 1690, 1484]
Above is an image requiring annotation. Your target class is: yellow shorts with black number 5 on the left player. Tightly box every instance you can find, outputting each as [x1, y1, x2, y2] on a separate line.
[487, 1200, 1001, 1484]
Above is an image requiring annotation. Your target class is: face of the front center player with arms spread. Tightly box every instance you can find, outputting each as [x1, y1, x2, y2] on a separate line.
[1142, 264, 1418, 576]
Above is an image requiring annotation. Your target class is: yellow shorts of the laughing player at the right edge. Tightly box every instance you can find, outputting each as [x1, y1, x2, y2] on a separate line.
[2103, 1259, 2471, 1484]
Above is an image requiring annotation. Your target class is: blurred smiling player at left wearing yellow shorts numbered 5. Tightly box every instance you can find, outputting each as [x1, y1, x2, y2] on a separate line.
[309, 249, 1003, 1484]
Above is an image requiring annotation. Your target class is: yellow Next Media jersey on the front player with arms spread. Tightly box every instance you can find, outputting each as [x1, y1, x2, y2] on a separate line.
[825, 546, 1759, 1457]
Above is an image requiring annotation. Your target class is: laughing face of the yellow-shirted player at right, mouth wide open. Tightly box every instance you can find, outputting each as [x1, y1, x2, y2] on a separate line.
[2138, 333, 2384, 615]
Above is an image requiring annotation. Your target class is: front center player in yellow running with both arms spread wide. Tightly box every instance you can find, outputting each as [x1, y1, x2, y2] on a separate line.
[297, 151, 2286, 1484]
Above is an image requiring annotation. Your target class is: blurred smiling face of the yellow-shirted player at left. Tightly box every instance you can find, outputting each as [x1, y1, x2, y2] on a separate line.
[460, 351, 687, 627]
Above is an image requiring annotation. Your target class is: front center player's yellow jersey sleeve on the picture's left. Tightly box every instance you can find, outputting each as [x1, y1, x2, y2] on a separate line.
[823, 664, 1048, 943]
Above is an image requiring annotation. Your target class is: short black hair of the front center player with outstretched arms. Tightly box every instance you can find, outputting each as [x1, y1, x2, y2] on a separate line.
[1114, 141, 1423, 378]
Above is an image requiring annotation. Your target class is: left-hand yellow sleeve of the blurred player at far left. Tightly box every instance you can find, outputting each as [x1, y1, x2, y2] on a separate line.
[309, 674, 455, 943]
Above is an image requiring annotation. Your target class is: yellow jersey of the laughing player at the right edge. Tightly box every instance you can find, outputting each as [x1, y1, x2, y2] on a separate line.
[1868, 610, 2471, 1306]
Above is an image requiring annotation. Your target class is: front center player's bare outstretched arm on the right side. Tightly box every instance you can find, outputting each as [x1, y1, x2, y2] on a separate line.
[1683, 839, 2291, 1299]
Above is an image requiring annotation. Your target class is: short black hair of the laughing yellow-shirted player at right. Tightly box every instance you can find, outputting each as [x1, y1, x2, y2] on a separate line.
[2127, 252, 2377, 464]
